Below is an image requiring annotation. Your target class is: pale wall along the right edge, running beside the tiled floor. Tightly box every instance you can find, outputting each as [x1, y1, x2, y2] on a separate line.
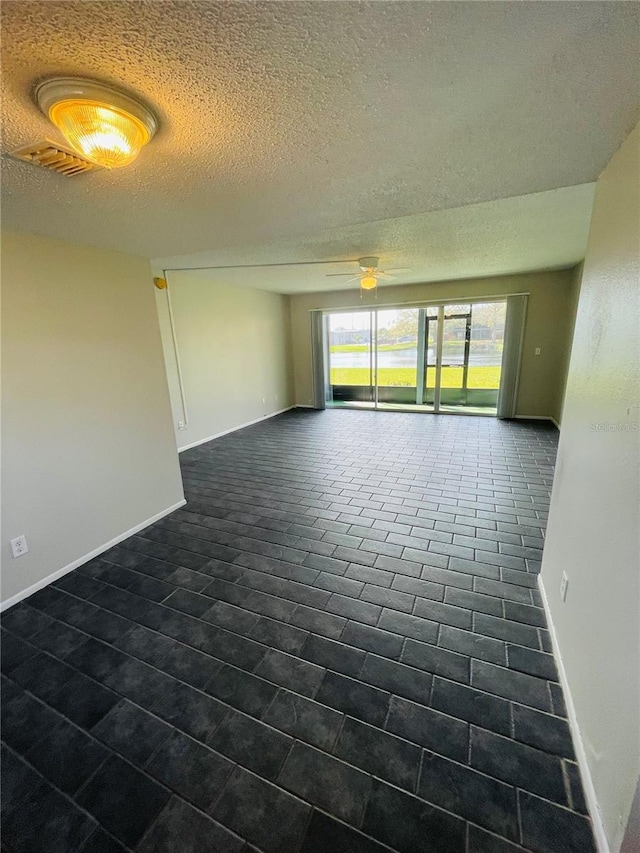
[542, 126, 640, 853]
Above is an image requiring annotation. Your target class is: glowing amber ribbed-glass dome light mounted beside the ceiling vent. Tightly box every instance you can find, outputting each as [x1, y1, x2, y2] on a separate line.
[36, 77, 158, 169]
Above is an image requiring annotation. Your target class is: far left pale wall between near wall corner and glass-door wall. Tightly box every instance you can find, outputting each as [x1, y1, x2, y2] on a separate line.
[156, 272, 293, 449]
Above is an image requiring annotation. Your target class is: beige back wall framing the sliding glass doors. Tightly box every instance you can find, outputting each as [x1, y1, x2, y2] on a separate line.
[291, 270, 575, 423]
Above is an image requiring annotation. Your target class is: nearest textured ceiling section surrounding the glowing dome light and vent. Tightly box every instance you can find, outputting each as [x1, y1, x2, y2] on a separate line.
[1, 0, 640, 290]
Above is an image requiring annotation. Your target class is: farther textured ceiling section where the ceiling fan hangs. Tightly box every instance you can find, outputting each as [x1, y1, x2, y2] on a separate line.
[153, 184, 595, 293]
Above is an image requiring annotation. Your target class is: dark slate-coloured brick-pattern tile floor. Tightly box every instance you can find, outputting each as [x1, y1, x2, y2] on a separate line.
[2, 411, 594, 853]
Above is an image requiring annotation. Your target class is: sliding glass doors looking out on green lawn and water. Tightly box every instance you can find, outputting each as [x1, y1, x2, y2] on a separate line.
[324, 299, 507, 416]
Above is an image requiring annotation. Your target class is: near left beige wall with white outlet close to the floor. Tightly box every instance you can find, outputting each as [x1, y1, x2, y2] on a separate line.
[2, 233, 183, 601]
